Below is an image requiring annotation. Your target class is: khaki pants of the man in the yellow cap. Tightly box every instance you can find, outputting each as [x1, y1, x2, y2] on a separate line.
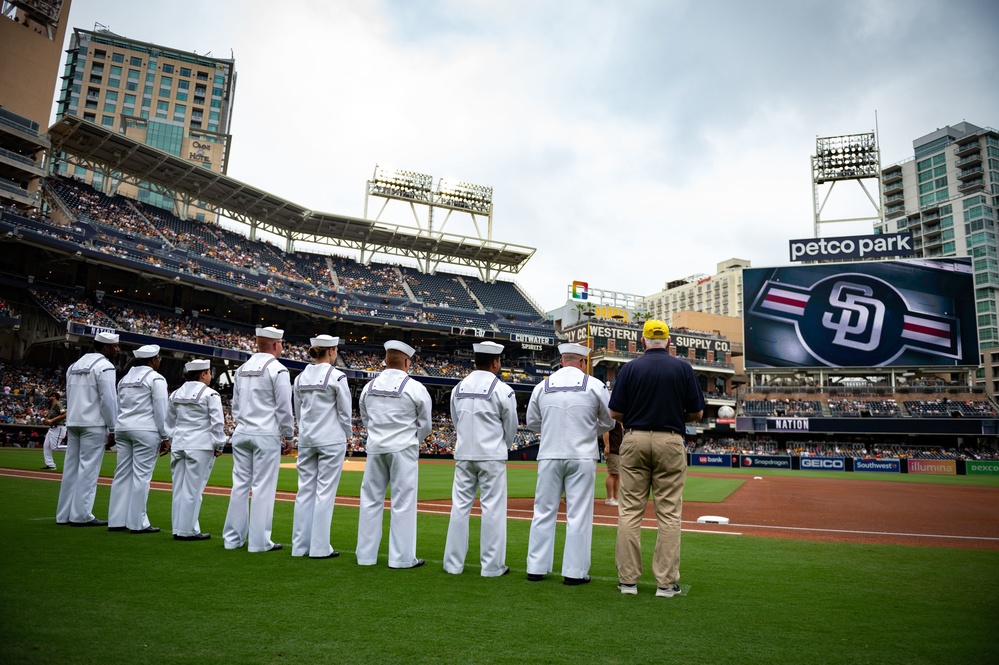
[616, 430, 687, 587]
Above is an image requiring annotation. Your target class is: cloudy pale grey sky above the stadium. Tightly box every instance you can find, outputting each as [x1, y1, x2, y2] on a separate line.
[52, 0, 999, 309]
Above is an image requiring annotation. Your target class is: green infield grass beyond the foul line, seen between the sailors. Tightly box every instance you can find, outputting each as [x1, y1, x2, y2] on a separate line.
[0, 449, 745, 503]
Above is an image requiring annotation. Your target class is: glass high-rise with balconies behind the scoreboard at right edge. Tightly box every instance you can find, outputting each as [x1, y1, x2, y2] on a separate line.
[875, 122, 999, 395]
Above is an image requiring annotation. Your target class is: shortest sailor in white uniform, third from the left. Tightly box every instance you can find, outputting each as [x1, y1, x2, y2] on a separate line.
[167, 359, 226, 540]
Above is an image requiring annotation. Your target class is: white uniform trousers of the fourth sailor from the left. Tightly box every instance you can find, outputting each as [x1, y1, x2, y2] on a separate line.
[222, 434, 281, 552]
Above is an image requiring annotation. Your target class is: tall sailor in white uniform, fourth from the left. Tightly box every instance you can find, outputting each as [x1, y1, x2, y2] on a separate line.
[222, 326, 295, 552]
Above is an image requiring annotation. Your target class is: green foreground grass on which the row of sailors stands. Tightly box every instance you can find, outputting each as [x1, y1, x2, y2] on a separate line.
[0, 478, 999, 665]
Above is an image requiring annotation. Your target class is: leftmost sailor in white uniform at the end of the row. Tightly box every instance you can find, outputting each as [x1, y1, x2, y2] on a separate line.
[56, 332, 118, 526]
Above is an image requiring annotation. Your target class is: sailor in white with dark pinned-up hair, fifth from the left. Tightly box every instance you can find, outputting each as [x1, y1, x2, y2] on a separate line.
[291, 335, 353, 559]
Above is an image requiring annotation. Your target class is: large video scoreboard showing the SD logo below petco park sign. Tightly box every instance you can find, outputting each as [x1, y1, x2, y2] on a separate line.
[742, 258, 978, 368]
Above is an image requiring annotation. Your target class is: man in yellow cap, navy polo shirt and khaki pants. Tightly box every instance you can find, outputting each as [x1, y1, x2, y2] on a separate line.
[609, 320, 704, 598]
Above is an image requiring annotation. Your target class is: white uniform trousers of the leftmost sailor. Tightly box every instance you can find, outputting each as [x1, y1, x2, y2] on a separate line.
[56, 427, 108, 524]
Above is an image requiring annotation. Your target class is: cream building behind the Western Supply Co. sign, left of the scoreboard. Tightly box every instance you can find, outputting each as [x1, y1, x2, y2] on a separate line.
[641, 259, 750, 325]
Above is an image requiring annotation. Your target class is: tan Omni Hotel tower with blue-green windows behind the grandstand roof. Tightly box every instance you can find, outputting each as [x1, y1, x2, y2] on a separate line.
[56, 25, 236, 219]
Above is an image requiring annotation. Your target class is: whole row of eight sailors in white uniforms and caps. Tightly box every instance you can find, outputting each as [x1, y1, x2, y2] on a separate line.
[56, 327, 614, 585]
